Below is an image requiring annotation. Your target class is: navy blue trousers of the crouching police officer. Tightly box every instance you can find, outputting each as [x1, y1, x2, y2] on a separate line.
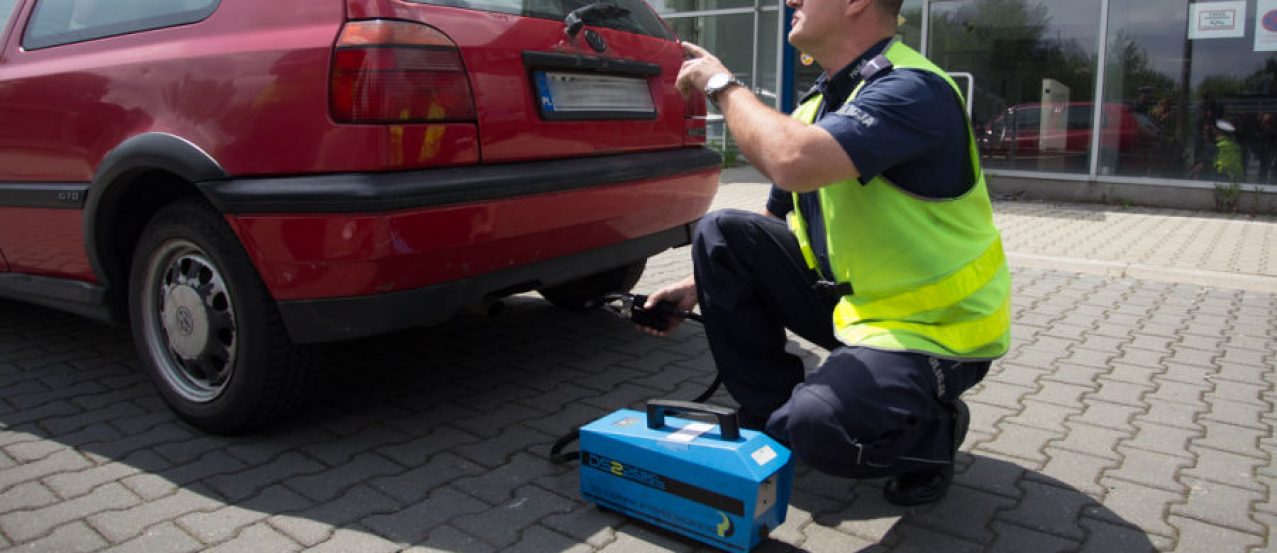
[692, 209, 988, 478]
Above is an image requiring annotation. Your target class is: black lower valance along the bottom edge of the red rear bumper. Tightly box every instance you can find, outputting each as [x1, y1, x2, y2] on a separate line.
[278, 222, 695, 344]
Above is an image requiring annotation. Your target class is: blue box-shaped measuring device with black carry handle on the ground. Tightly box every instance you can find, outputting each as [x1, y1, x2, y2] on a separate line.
[580, 400, 793, 552]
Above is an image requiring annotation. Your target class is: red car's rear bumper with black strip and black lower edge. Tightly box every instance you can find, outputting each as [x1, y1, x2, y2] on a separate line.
[200, 148, 719, 342]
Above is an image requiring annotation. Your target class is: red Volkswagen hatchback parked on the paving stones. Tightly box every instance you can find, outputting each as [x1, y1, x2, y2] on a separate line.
[0, 0, 719, 432]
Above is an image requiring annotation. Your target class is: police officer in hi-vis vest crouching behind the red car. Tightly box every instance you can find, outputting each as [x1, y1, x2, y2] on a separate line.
[649, 0, 1010, 506]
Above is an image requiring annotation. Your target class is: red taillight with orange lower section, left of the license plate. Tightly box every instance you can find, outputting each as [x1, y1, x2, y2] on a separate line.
[328, 19, 475, 123]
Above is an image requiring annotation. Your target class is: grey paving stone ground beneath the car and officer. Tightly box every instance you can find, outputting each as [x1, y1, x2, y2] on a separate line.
[0, 174, 1277, 553]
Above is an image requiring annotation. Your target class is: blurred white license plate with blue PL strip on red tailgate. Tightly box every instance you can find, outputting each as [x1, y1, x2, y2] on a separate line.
[533, 72, 656, 119]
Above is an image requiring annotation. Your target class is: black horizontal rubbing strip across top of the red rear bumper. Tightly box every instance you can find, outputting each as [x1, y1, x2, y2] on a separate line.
[199, 148, 722, 213]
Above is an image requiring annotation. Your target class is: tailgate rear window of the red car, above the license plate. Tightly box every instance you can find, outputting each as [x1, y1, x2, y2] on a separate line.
[410, 0, 674, 40]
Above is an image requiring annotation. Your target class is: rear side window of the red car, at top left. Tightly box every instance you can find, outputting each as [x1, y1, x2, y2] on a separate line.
[23, 0, 220, 50]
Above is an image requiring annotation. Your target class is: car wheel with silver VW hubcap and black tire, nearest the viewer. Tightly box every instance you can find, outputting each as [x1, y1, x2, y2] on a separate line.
[129, 198, 306, 434]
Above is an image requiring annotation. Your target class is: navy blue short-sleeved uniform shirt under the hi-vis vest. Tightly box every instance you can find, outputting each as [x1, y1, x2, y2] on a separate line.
[767, 40, 974, 277]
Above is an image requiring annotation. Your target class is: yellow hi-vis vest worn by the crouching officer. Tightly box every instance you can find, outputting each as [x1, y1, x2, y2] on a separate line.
[789, 41, 1011, 360]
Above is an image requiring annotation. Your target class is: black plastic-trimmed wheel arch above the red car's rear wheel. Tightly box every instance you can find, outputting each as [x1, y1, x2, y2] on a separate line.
[84, 133, 229, 321]
